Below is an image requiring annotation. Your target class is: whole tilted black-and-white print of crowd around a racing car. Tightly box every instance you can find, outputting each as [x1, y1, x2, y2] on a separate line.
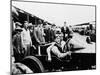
[10, 0, 96, 75]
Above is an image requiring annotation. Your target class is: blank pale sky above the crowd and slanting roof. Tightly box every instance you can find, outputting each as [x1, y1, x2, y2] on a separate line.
[12, 1, 95, 26]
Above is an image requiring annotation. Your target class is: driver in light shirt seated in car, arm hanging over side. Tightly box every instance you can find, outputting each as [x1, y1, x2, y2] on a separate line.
[47, 31, 71, 61]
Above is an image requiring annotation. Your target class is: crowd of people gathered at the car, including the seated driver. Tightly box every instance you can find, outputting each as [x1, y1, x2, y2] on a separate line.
[12, 20, 73, 61]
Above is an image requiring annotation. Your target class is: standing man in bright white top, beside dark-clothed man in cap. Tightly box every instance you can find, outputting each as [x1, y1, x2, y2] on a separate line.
[21, 21, 32, 56]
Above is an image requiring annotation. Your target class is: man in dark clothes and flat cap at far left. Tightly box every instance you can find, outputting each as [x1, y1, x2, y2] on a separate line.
[12, 27, 23, 61]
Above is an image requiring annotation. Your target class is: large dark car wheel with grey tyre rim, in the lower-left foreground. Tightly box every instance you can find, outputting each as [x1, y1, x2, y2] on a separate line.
[21, 56, 44, 73]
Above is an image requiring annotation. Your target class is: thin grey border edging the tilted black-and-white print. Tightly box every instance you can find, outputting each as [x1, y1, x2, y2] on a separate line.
[10, 0, 97, 75]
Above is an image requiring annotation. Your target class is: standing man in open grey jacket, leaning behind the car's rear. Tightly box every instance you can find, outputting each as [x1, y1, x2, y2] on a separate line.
[34, 20, 45, 55]
